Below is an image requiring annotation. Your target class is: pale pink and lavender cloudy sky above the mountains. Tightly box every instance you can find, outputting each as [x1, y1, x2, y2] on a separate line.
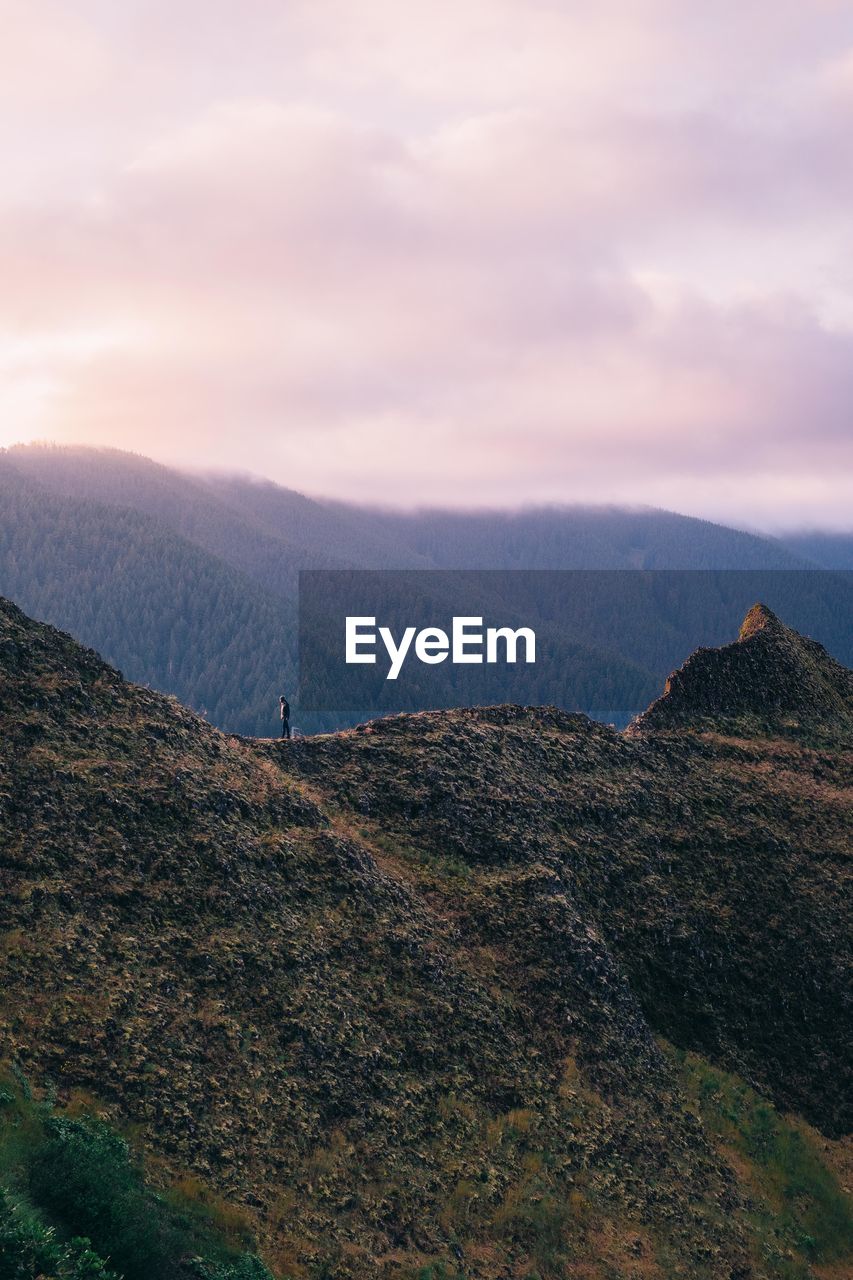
[0, 0, 853, 529]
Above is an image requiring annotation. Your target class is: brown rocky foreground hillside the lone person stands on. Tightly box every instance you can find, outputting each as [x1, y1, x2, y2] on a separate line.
[0, 591, 853, 1280]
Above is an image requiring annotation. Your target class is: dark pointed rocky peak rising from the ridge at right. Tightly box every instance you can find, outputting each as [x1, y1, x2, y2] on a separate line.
[634, 604, 853, 736]
